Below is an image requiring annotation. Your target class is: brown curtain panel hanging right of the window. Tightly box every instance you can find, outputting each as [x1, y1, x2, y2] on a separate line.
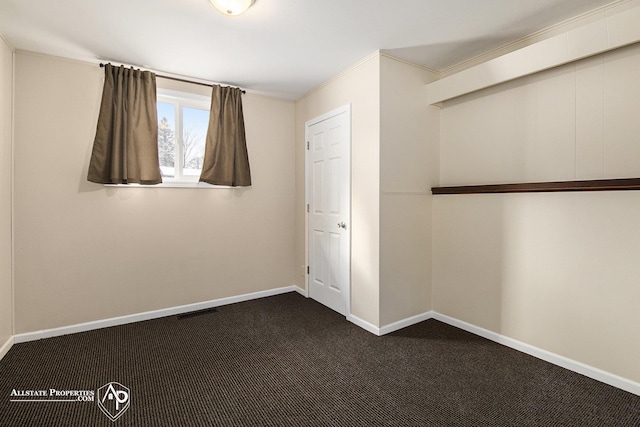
[200, 85, 251, 187]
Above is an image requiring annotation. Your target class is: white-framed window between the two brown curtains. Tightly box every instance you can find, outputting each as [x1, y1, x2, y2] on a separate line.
[157, 89, 211, 183]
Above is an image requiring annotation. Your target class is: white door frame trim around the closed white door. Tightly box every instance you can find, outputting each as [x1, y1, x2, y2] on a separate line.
[303, 104, 352, 319]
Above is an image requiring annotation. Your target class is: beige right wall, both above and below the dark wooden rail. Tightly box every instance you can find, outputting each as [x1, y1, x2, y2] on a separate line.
[433, 46, 640, 382]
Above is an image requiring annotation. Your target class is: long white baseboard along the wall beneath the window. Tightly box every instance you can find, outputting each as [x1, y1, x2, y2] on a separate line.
[13, 286, 299, 344]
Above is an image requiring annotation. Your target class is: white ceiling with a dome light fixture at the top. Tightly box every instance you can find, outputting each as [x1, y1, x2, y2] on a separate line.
[0, 0, 612, 99]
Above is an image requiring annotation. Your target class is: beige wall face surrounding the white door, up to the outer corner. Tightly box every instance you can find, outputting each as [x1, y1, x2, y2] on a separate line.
[295, 53, 380, 325]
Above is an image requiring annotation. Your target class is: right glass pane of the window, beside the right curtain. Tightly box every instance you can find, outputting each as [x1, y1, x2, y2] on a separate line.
[182, 108, 209, 176]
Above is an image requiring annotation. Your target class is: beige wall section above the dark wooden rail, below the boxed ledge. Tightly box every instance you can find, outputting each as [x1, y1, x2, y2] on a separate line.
[441, 45, 640, 185]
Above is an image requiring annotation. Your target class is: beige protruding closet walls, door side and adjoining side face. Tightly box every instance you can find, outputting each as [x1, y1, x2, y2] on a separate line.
[296, 52, 439, 327]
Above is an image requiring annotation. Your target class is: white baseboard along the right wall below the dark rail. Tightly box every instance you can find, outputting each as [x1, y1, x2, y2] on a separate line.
[433, 312, 640, 396]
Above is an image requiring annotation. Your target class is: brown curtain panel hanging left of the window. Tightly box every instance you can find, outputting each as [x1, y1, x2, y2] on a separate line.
[87, 64, 162, 184]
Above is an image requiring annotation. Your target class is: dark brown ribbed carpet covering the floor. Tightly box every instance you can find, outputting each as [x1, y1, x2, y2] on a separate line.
[0, 293, 640, 427]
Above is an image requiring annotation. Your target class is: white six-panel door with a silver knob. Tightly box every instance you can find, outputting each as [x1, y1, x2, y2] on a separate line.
[305, 106, 351, 316]
